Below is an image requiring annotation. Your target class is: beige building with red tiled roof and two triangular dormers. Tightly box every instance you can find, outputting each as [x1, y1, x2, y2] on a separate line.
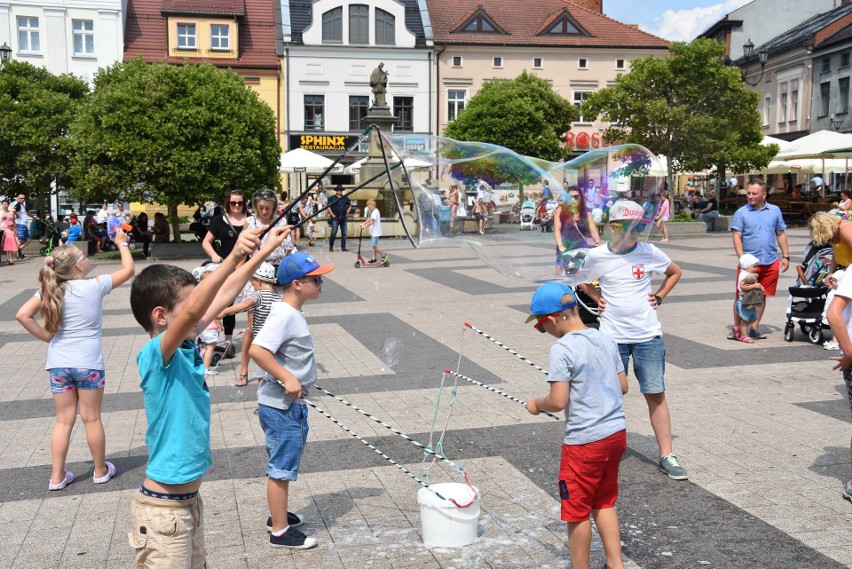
[426, 0, 669, 152]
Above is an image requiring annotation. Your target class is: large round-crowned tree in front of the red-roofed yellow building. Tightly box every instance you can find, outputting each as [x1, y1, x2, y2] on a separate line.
[71, 59, 281, 235]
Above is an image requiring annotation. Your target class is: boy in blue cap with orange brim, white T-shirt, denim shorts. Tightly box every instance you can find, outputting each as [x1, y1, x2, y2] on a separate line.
[249, 253, 334, 549]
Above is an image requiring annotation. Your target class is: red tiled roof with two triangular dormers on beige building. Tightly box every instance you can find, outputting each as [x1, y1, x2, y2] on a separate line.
[426, 0, 669, 49]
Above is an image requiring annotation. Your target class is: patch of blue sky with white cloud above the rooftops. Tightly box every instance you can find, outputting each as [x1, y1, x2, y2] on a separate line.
[603, 0, 751, 41]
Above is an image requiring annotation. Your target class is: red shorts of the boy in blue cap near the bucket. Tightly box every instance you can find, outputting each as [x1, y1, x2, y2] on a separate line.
[559, 430, 627, 522]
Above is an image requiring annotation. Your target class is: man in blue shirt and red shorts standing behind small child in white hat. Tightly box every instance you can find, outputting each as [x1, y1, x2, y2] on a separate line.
[728, 179, 790, 340]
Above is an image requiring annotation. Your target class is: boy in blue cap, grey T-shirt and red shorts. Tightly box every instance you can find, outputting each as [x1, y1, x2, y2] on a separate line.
[527, 283, 627, 569]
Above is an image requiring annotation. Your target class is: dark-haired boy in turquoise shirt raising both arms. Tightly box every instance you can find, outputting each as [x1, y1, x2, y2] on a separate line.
[128, 227, 290, 568]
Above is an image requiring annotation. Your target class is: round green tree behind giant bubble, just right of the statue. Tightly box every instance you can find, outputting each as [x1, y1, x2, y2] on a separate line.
[444, 72, 577, 183]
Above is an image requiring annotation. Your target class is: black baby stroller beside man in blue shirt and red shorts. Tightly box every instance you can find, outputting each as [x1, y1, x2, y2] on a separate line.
[784, 246, 833, 344]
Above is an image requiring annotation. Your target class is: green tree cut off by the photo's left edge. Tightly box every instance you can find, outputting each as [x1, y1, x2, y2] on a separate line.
[0, 61, 89, 208]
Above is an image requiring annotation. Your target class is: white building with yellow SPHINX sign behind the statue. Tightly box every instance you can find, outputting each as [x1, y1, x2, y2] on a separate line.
[275, 0, 433, 162]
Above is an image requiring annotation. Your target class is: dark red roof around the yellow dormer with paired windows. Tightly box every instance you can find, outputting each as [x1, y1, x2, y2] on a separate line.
[124, 0, 278, 71]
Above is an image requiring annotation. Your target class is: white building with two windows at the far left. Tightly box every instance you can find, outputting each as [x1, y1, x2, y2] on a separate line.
[0, 0, 124, 82]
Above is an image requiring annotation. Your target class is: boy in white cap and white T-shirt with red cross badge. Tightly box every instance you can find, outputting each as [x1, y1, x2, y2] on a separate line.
[580, 200, 687, 480]
